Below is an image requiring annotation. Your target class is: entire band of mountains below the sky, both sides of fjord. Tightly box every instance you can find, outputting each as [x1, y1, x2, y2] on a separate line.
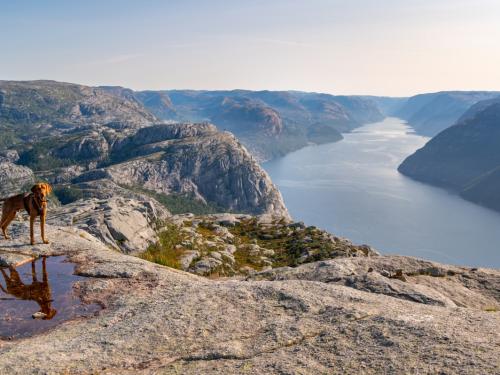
[0, 81, 500, 213]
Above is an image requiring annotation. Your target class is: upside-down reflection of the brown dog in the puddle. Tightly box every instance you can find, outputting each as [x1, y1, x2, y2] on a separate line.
[0, 257, 57, 320]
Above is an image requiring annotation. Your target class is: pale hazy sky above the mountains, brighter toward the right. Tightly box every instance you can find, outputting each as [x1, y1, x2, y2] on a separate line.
[0, 0, 500, 96]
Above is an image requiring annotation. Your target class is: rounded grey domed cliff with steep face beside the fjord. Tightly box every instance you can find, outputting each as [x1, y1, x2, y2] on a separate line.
[102, 124, 288, 217]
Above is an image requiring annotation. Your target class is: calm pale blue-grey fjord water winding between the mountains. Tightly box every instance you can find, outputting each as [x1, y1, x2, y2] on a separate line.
[264, 118, 500, 268]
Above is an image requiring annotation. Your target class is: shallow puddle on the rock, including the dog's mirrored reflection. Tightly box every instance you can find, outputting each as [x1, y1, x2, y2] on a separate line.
[0, 256, 100, 339]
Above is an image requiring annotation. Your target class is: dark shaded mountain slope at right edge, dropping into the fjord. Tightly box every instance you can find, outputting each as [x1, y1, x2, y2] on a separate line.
[398, 98, 500, 210]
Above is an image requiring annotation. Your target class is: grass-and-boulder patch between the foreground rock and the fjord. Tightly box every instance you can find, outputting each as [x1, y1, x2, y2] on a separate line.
[146, 213, 378, 277]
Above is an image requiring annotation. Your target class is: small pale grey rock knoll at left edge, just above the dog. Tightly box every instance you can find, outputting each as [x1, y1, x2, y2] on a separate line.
[0, 158, 35, 198]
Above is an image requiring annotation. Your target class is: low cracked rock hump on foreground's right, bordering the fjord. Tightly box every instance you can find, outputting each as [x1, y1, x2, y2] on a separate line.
[248, 256, 500, 310]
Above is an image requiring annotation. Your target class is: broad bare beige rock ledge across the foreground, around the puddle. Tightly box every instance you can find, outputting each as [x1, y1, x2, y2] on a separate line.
[0, 223, 500, 374]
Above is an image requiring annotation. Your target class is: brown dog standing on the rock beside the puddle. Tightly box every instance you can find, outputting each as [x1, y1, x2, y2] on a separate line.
[0, 183, 52, 245]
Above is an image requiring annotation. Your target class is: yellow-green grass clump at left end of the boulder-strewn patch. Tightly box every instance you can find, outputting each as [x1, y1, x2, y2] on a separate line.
[139, 224, 184, 269]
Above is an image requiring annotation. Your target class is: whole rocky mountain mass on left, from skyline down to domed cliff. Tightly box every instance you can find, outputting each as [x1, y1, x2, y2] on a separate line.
[0, 81, 288, 217]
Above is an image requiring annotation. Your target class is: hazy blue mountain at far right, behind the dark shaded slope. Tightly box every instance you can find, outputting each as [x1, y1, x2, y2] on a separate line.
[394, 91, 500, 136]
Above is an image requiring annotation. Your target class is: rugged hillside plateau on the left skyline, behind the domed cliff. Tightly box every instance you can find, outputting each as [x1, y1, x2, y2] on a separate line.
[0, 81, 157, 148]
